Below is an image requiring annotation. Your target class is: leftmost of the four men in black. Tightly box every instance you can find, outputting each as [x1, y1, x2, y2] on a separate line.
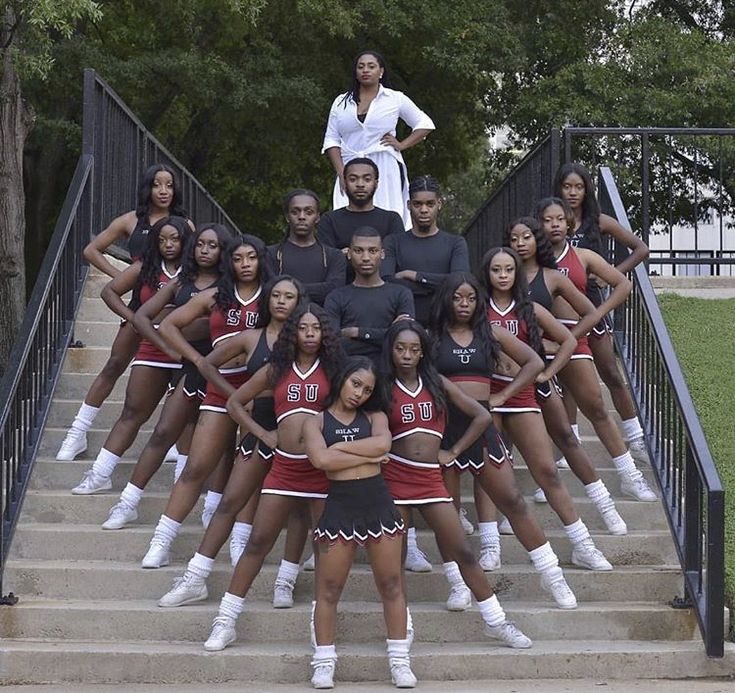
[266, 190, 347, 305]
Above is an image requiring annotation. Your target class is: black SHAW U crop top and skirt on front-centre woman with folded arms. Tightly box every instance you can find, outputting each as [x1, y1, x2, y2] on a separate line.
[314, 410, 404, 546]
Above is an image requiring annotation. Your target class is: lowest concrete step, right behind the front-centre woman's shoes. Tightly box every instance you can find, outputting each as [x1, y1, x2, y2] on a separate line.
[3, 629, 735, 690]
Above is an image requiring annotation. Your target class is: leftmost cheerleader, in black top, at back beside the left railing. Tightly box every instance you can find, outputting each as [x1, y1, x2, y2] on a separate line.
[56, 164, 194, 462]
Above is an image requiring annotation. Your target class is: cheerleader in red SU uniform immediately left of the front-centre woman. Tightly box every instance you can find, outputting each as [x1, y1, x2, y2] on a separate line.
[204, 303, 344, 651]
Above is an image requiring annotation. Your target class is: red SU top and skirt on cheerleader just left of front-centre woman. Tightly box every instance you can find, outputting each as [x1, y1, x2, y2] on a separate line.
[261, 359, 329, 498]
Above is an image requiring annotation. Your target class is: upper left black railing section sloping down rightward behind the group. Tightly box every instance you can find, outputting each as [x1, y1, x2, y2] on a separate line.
[82, 68, 238, 251]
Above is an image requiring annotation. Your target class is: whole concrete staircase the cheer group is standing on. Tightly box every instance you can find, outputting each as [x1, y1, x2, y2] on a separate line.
[0, 264, 735, 690]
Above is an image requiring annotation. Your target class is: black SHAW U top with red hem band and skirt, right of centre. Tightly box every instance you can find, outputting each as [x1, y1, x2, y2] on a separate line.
[436, 333, 510, 474]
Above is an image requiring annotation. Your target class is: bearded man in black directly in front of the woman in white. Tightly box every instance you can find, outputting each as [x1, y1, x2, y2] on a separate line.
[318, 158, 405, 255]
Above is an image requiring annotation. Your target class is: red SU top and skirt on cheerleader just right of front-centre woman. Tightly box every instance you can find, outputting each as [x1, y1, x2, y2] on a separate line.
[383, 377, 452, 505]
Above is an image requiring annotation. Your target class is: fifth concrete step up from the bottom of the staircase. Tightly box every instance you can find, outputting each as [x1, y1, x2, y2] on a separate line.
[22, 486, 667, 533]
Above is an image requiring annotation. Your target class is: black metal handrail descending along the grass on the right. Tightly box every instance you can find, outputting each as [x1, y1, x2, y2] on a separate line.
[599, 167, 725, 657]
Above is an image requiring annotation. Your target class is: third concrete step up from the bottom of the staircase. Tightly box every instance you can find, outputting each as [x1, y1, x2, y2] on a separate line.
[4, 559, 682, 604]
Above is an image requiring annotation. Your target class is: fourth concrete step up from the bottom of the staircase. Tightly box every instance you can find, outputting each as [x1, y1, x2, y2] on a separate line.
[11, 524, 677, 570]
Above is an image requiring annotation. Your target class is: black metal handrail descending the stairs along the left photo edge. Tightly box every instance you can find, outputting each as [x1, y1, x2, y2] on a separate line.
[0, 155, 93, 594]
